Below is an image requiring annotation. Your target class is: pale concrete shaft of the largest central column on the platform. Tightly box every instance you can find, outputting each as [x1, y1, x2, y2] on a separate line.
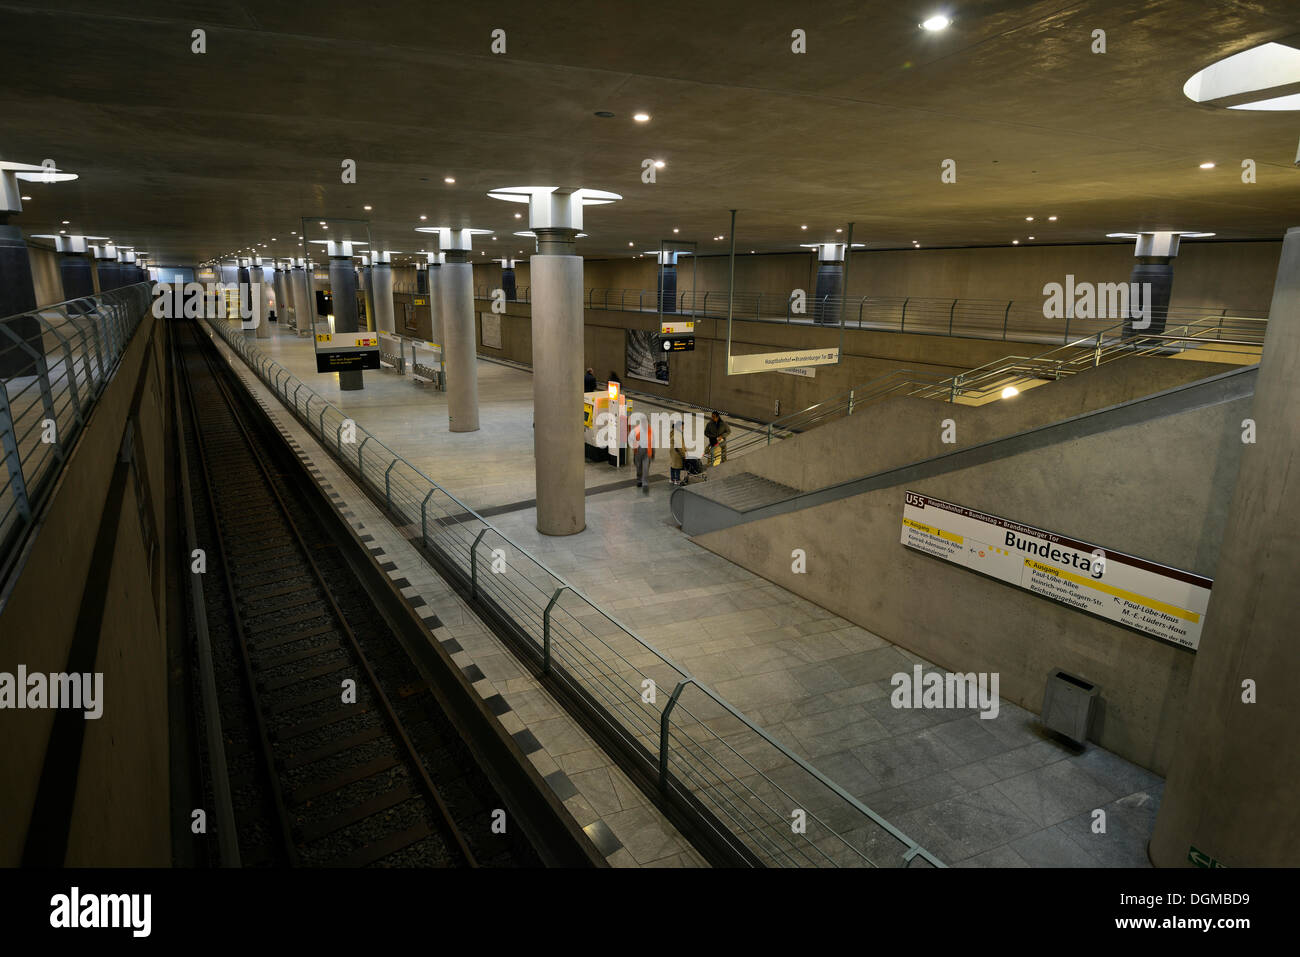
[528, 237, 586, 534]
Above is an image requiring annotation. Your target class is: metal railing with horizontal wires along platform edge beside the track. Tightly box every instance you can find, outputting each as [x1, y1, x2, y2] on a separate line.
[197, 320, 944, 867]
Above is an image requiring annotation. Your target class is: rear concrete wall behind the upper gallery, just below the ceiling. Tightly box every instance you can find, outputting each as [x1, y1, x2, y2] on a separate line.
[577, 239, 1282, 315]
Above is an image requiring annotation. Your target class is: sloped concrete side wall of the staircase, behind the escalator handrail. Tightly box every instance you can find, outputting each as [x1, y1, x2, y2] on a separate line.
[714, 358, 1225, 492]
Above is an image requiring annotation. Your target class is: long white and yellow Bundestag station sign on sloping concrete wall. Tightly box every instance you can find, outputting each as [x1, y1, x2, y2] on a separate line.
[902, 492, 1214, 651]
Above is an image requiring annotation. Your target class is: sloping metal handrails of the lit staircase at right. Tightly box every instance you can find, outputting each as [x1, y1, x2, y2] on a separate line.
[727, 316, 1268, 459]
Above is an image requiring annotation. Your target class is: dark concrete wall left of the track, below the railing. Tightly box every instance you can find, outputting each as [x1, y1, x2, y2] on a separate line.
[0, 308, 172, 866]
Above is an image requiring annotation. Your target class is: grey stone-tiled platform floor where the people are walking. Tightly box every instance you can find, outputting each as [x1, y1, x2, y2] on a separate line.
[239, 326, 1164, 867]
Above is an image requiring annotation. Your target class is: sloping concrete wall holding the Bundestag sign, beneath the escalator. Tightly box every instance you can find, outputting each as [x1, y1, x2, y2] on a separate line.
[697, 390, 1251, 774]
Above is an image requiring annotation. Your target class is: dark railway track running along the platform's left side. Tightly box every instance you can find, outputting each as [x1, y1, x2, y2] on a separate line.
[172, 321, 541, 867]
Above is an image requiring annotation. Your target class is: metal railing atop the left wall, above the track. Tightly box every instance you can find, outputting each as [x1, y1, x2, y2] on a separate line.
[0, 282, 152, 579]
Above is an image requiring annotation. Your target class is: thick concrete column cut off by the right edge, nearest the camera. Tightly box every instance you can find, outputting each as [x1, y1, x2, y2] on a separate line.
[1149, 228, 1300, 867]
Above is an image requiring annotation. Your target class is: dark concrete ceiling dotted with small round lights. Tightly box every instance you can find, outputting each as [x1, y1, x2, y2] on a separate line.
[0, 0, 1300, 264]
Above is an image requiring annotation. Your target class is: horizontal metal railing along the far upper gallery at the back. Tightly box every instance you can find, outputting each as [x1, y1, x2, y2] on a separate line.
[475, 286, 1268, 345]
